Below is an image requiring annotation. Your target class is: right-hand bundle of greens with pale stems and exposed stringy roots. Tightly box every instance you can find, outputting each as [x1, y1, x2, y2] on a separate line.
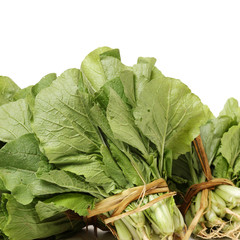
[173, 98, 240, 239]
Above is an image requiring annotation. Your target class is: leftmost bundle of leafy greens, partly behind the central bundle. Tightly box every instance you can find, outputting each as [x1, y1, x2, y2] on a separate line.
[0, 74, 85, 240]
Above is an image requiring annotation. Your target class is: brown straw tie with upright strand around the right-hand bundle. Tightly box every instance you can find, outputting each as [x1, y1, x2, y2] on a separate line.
[180, 135, 234, 240]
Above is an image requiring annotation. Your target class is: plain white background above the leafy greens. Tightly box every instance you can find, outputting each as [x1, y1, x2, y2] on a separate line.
[0, 0, 240, 115]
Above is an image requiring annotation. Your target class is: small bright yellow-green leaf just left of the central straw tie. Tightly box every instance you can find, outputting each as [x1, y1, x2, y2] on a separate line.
[45, 193, 95, 216]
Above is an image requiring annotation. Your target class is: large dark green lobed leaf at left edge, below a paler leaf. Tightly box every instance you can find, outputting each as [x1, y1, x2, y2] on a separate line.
[0, 134, 69, 204]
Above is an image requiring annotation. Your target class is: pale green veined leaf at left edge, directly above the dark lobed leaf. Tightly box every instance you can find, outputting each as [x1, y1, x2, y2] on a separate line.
[0, 99, 32, 142]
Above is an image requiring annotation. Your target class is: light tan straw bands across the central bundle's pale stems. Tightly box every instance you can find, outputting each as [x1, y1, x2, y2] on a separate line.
[87, 178, 176, 224]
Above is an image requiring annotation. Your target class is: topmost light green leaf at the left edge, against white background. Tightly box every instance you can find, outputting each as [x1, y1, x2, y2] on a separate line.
[0, 76, 20, 105]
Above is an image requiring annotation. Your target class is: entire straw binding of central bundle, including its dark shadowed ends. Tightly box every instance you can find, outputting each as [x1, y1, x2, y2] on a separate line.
[65, 178, 176, 240]
